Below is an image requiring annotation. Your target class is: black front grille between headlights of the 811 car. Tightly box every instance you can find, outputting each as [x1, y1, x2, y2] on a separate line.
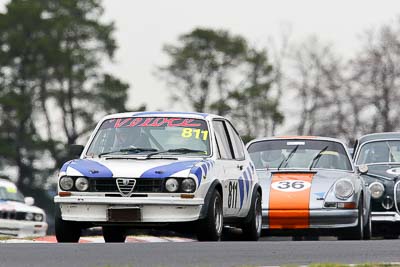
[90, 178, 164, 193]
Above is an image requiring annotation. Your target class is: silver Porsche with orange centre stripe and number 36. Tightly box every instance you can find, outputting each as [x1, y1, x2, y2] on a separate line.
[247, 136, 371, 239]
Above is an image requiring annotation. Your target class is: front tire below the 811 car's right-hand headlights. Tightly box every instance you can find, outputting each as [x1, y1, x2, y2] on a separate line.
[196, 190, 224, 241]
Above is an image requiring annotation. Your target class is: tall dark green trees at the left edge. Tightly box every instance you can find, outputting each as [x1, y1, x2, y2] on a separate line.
[0, 0, 144, 221]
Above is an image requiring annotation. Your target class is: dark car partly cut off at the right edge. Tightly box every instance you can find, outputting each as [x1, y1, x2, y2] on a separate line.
[354, 133, 400, 238]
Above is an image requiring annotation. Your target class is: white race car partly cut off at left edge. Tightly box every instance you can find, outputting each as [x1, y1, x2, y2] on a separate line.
[0, 179, 47, 238]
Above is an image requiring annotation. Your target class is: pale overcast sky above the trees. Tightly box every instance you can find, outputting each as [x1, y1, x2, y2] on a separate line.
[99, 0, 400, 110]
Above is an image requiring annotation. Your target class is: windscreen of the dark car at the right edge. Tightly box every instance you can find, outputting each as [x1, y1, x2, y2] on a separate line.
[357, 140, 400, 165]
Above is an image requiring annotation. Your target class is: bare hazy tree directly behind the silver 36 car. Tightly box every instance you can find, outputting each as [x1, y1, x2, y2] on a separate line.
[290, 37, 351, 137]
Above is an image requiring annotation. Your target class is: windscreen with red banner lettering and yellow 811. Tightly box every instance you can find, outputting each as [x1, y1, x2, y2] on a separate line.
[86, 117, 210, 157]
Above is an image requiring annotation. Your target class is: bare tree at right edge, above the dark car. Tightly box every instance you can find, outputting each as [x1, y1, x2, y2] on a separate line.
[352, 22, 400, 132]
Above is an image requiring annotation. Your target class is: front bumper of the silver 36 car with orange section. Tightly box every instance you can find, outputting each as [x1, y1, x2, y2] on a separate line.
[262, 209, 358, 229]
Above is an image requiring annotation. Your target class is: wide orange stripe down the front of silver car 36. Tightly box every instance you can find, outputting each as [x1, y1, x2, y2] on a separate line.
[268, 173, 314, 229]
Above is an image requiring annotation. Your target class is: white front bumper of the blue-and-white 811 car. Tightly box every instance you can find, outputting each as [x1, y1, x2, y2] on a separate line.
[54, 196, 204, 223]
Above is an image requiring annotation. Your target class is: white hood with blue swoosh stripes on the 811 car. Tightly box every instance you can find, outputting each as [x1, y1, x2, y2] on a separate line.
[60, 158, 214, 183]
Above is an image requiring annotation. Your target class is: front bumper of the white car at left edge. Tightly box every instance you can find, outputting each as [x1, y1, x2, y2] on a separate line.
[0, 219, 48, 238]
